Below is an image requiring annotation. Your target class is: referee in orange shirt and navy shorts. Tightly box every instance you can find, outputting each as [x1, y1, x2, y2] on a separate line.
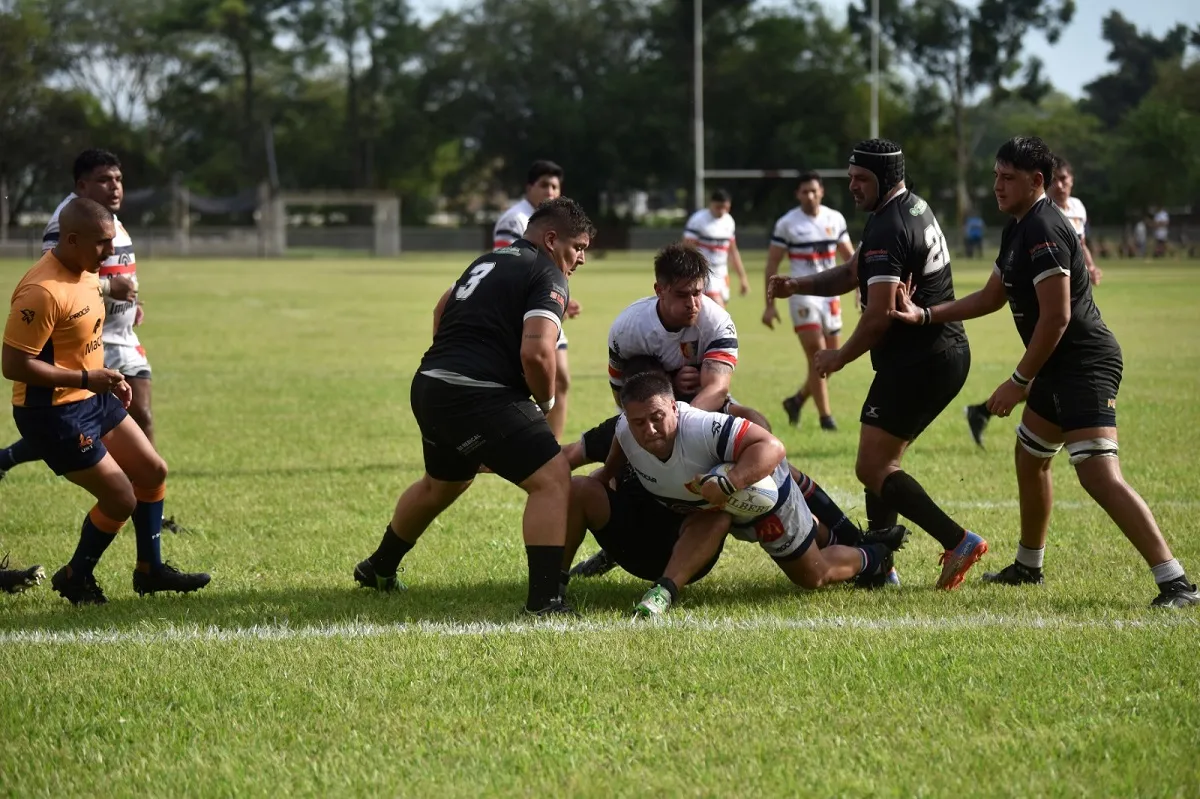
[2, 198, 209, 605]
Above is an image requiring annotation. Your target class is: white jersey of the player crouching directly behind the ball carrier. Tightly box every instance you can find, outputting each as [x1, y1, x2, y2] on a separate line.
[608, 296, 738, 389]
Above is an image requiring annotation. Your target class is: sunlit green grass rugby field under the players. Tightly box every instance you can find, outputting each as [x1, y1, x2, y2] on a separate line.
[0, 253, 1200, 797]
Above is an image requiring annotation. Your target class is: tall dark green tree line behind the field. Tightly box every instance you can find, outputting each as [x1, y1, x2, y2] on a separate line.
[0, 0, 1200, 223]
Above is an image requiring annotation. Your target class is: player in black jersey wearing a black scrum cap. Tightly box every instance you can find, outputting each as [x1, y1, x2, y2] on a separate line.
[768, 139, 988, 589]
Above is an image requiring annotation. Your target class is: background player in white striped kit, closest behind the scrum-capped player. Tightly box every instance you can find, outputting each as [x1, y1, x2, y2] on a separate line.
[762, 172, 854, 431]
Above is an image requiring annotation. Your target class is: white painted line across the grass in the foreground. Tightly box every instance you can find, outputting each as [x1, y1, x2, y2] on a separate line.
[0, 612, 1200, 645]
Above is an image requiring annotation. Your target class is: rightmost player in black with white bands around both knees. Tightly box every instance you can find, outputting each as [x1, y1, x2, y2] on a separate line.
[892, 137, 1200, 607]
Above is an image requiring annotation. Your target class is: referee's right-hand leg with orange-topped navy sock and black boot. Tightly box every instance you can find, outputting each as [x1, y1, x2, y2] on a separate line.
[102, 416, 211, 596]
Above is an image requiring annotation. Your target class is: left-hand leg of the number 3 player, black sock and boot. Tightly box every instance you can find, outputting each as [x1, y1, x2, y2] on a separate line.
[354, 473, 473, 593]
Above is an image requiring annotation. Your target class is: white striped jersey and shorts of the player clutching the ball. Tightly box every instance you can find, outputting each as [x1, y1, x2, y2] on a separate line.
[617, 402, 815, 558]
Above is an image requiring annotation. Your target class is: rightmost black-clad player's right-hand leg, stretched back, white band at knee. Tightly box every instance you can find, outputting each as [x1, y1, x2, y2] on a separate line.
[1067, 427, 1200, 607]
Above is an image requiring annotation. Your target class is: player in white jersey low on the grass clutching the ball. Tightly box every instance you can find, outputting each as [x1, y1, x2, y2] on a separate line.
[564, 372, 902, 617]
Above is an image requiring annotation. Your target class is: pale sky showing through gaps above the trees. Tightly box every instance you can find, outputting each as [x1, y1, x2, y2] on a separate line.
[413, 0, 1200, 97]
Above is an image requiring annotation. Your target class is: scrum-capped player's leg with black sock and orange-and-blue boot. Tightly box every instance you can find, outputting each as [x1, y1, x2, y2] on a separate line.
[854, 425, 988, 590]
